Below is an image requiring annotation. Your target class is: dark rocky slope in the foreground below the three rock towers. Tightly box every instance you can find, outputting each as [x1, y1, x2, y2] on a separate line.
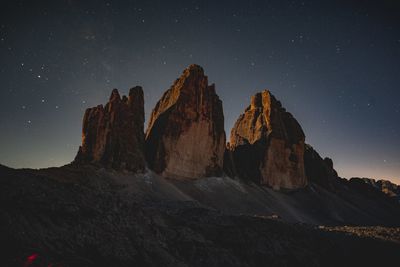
[0, 165, 400, 266]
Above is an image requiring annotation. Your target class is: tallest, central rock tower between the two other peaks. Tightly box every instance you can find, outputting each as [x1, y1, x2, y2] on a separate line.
[146, 65, 225, 179]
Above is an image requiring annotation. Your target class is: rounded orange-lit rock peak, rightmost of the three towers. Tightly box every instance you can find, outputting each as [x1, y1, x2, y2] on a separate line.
[229, 91, 307, 190]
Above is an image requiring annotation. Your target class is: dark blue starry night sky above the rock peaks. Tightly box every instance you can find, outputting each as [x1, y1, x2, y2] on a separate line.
[0, 0, 400, 183]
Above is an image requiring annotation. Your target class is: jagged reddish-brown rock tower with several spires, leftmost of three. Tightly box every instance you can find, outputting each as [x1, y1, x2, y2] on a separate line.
[75, 86, 145, 171]
